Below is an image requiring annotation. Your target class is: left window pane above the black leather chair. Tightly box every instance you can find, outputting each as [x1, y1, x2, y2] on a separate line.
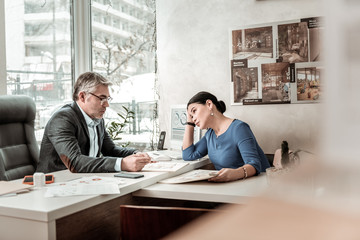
[5, 0, 72, 142]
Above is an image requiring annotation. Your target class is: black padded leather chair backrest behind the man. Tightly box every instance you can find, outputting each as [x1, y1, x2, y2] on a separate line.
[0, 95, 39, 181]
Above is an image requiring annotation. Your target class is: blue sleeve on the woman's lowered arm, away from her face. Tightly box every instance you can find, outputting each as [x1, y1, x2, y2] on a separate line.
[234, 123, 261, 174]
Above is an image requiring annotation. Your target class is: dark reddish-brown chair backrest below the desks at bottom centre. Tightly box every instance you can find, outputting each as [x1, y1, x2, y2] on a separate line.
[120, 205, 219, 240]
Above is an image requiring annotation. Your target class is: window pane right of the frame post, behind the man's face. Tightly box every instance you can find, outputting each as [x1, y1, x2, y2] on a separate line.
[91, 0, 156, 149]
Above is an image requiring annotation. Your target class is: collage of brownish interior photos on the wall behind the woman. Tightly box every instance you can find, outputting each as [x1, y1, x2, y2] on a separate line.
[230, 17, 324, 105]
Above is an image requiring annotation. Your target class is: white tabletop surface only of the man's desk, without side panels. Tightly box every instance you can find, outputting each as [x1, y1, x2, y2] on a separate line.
[0, 159, 210, 221]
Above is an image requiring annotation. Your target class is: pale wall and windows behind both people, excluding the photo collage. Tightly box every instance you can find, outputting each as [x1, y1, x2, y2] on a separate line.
[0, 0, 360, 182]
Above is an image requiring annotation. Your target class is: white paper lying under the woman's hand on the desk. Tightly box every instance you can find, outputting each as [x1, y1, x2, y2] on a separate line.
[160, 169, 218, 183]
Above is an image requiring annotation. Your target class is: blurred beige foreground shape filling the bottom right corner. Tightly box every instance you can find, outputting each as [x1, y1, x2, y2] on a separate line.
[166, 159, 360, 240]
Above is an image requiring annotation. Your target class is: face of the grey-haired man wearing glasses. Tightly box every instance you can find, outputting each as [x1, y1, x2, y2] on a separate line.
[79, 85, 110, 119]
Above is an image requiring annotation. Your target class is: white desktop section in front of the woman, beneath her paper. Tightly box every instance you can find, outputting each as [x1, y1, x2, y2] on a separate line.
[133, 173, 268, 203]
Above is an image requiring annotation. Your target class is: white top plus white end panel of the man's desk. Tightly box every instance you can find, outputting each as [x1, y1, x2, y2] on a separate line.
[0, 159, 210, 240]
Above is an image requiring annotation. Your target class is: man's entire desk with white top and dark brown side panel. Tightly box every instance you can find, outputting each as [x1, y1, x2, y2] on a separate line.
[0, 159, 210, 240]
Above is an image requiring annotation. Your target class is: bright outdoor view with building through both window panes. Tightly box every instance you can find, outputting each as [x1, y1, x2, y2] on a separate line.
[1, 0, 157, 148]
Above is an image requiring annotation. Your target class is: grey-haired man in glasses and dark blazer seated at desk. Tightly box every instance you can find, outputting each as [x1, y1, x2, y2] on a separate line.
[36, 72, 150, 173]
